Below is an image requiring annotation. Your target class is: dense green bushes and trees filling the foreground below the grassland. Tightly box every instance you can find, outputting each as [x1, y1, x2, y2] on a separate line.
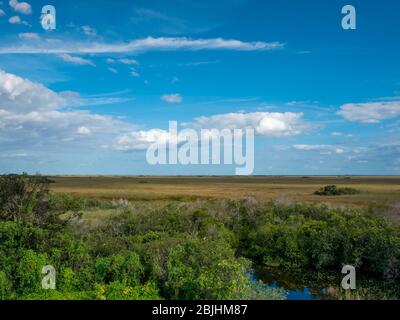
[0, 175, 400, 299]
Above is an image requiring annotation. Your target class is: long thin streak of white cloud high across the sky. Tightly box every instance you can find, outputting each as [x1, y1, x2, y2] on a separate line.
[0, 37, 284, 54]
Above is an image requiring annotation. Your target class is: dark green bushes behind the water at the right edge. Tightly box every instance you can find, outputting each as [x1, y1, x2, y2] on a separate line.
[241, 205, 400, 278]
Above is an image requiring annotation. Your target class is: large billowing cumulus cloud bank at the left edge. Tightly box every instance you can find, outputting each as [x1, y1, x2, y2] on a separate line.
[0, 70, 134, 149]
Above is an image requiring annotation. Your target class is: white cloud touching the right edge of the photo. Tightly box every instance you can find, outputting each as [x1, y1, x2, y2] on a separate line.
[337, 101, 400, 124]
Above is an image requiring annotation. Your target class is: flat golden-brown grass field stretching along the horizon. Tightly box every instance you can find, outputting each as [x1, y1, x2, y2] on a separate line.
[51, 176, 400, 208]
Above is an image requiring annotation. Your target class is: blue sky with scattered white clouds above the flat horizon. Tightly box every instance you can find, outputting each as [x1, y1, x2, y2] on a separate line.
[0, 0, 400, 175]
